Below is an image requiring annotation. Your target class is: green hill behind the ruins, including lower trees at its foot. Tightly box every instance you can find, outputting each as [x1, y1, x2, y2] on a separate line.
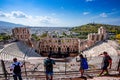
[71, 23, 120, 38]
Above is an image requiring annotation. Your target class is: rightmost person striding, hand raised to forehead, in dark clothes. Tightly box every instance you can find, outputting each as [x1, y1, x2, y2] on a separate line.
[98, 52, 112, 76]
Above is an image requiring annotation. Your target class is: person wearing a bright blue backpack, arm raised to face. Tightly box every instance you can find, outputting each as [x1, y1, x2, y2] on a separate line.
[76, 54, 88, 77]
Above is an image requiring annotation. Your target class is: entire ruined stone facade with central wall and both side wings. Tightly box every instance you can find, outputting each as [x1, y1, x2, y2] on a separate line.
[12, 27, 107, 54]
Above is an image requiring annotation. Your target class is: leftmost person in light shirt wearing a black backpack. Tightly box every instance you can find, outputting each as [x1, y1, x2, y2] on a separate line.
[10, 58, 23, 80]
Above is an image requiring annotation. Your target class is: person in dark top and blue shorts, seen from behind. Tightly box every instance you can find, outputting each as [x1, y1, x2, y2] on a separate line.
[44, 55, 55, 80]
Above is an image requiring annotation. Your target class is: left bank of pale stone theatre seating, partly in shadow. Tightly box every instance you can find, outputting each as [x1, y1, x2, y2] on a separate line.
[0, 42, 40, 60]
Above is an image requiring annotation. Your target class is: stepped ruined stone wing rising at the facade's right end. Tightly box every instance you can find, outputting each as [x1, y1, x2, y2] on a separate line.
[79, 27, 107, 52]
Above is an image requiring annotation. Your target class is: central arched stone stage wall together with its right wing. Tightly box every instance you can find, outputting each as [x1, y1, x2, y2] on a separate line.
[37, 27, 107, 53]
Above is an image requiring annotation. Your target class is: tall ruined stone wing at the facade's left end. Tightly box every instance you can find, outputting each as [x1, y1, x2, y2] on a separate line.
[12, 27, 30, 41]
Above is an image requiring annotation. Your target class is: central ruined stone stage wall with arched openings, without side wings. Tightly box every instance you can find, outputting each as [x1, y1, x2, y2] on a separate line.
[38, 37, 78, 53]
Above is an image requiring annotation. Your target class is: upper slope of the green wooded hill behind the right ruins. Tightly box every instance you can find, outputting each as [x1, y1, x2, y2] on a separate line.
[71, 23, 120, 34]
